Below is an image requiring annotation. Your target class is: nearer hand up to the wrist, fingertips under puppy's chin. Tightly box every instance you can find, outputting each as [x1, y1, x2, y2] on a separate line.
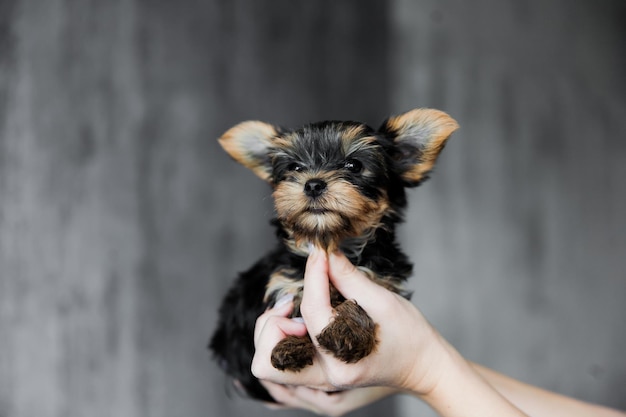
[252, 245, 446, 393]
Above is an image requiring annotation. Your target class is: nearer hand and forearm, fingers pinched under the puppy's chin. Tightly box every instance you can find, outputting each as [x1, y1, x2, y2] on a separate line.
[252, 250, 525, 417]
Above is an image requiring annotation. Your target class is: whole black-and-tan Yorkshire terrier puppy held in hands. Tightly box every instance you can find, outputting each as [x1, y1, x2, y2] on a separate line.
[209, 109, 458, 402]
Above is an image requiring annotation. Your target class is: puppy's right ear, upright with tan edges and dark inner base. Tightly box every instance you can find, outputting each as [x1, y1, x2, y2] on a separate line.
[380, 109, 459, 187]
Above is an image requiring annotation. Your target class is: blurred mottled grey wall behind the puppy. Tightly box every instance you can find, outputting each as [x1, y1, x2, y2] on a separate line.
[0, 0, 626, 417]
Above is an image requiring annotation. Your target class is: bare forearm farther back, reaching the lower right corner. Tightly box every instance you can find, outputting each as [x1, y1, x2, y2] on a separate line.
[470, 363, 626, 417]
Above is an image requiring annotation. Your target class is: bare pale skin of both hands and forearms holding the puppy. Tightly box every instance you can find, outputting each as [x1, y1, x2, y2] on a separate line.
[252, 249, 626, 417]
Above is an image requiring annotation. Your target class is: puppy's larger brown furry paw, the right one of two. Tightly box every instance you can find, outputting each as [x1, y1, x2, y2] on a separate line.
[317, 300, 378, 363]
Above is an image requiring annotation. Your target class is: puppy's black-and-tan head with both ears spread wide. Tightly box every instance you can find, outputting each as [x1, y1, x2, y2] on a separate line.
[219, 109, 458, 250]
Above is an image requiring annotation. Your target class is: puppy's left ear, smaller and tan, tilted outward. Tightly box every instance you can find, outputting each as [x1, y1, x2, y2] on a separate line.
[219, 120, 279, 181]
